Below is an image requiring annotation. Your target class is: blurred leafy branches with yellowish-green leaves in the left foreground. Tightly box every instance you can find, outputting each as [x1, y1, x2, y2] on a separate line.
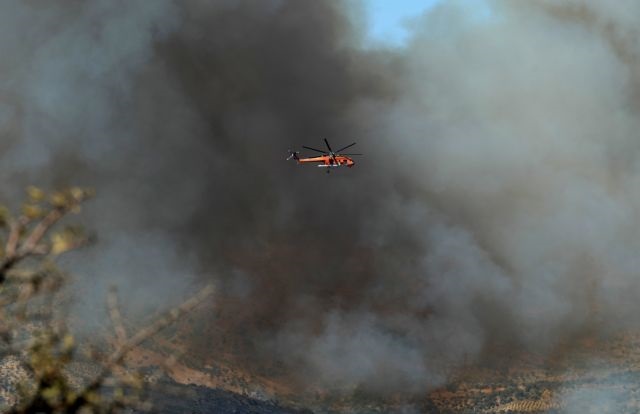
[0, 187, 212, 413]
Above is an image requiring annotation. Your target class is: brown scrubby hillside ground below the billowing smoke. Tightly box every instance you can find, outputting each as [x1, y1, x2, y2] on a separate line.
[5, 292, 640, 414]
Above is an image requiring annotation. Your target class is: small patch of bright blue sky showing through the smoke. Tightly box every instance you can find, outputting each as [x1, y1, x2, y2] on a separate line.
[364, 0, 441, 46]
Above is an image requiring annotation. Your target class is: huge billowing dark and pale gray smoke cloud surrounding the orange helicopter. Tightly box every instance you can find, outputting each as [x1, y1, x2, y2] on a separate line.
[0, 0, 640, 391]
